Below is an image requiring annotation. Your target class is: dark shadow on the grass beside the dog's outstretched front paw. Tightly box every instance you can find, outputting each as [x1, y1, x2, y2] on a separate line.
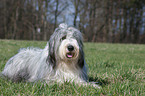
[89, 77, 110, 86]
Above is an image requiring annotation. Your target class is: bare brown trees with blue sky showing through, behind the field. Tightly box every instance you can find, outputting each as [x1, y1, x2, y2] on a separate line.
[0, 0, 145, 43]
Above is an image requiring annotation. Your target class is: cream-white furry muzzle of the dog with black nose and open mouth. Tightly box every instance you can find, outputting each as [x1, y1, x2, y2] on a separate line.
[58, 39, 79, 61]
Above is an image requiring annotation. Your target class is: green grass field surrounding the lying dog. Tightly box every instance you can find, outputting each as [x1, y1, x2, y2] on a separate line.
[0, 40, 145, 96]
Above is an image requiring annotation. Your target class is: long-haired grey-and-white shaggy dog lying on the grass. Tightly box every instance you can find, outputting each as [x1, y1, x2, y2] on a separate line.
[2, 23, 99, 88]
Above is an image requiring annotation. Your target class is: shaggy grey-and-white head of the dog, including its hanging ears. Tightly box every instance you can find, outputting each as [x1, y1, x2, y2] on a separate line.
[48, 24, 84, 67]
